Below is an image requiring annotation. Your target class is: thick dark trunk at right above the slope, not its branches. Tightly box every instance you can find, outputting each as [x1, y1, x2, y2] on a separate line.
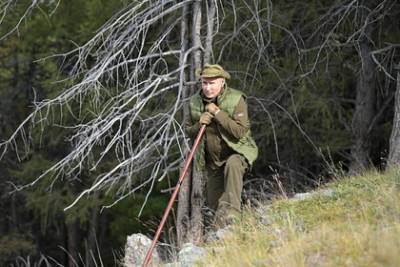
[350, 18, 376, 174]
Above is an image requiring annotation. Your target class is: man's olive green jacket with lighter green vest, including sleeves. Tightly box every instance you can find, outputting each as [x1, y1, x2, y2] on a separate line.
[186, 87, 258, 170]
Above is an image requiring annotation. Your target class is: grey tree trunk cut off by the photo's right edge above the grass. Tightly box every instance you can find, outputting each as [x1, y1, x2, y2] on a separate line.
[388, 63, 400, 167]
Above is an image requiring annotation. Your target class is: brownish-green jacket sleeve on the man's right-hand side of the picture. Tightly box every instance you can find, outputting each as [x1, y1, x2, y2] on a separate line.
[214, 97, 250, 139]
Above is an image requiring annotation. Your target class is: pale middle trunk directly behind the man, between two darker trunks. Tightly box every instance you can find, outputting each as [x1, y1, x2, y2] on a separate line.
[189, 1, 205, 243]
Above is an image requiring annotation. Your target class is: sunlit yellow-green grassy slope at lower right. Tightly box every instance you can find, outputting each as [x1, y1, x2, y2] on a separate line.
[200, 170, 400, 267]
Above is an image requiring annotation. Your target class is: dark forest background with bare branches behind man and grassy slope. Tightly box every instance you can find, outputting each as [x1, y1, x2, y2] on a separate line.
[0, 0, 400, 266]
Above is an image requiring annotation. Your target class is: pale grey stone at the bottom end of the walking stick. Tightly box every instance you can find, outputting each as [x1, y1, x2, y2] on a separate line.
[124, 234, 160, 267]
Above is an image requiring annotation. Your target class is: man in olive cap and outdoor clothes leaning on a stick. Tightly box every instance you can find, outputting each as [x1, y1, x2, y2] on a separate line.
[186, 65, 258, 227]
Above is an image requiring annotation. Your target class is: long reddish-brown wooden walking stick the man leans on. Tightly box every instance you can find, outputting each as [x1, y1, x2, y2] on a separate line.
[142, 125, 206, 267]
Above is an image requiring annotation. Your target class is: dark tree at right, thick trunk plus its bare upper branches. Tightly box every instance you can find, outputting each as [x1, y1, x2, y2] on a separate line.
[272, 0, 395, 173]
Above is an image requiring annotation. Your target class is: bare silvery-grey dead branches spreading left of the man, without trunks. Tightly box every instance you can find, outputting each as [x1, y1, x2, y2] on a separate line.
[0, 0, 195, 214]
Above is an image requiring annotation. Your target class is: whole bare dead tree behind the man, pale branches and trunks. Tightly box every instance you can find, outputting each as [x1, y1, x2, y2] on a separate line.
[0, 0, 225, 248]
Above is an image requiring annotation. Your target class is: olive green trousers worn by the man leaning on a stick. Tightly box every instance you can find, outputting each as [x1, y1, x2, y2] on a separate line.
[206, 154, 249, 225]
